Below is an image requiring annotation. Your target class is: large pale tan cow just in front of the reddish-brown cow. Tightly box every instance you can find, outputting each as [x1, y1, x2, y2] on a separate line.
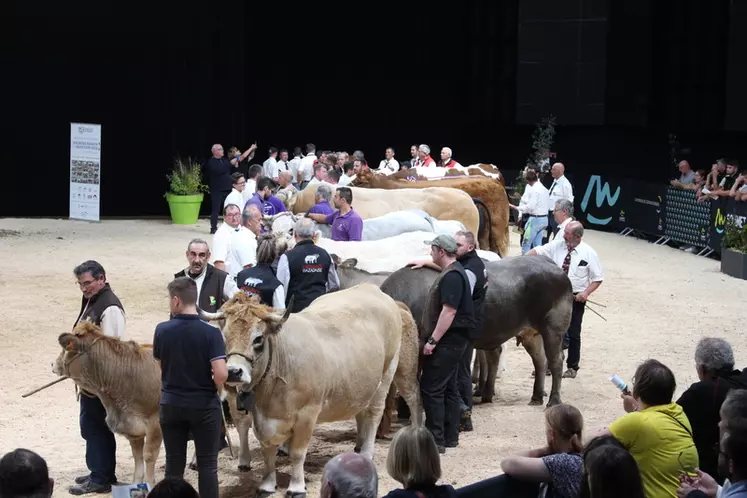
[283, 182, 480, 233]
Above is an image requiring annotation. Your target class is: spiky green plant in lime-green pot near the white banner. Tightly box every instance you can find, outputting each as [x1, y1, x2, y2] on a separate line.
[165, 157, 208, 225]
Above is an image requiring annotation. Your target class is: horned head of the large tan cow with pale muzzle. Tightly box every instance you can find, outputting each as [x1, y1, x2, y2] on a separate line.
[201, 292, 293, 391]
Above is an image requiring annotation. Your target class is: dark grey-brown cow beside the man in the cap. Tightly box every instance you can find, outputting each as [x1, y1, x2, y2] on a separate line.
[381, 256, 573, 406]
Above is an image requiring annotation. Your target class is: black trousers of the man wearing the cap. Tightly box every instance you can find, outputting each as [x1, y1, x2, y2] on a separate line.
[420, 342, 467, 446]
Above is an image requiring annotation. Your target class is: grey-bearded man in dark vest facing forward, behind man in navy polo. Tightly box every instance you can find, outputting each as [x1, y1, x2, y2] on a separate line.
[174, 239, 239, 313]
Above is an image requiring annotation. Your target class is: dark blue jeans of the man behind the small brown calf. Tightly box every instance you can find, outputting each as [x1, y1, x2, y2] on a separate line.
[80, 394, 117, 485]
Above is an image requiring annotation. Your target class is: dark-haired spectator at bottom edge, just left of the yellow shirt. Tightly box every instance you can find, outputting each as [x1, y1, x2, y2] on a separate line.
[584, 444, 645, 498]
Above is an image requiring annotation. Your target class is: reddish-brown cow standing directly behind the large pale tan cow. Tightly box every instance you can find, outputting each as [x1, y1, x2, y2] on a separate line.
[352, 170, 509, 256]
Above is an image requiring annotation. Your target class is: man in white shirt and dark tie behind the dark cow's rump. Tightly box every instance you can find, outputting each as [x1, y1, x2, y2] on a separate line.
[528, 221, 604, 379]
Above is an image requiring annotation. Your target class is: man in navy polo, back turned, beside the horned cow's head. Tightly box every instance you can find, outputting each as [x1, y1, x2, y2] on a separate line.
[153, 277, 228, 498]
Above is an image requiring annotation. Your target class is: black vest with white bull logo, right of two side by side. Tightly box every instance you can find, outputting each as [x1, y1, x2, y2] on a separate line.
[285, 240, 332, 313]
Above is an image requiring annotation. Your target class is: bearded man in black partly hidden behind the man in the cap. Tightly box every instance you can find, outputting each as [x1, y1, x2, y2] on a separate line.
[408, 231, 488, 431]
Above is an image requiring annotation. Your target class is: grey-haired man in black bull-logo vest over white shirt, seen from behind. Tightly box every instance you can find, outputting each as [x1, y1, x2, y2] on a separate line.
[277, 218, 340, 313]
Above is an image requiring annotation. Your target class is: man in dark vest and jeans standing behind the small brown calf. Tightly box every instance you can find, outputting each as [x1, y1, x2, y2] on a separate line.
[70, 261, 125, 495]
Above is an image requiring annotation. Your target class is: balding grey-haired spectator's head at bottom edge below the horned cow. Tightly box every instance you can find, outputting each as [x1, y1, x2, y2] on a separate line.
[319, 453, 379, 498]
